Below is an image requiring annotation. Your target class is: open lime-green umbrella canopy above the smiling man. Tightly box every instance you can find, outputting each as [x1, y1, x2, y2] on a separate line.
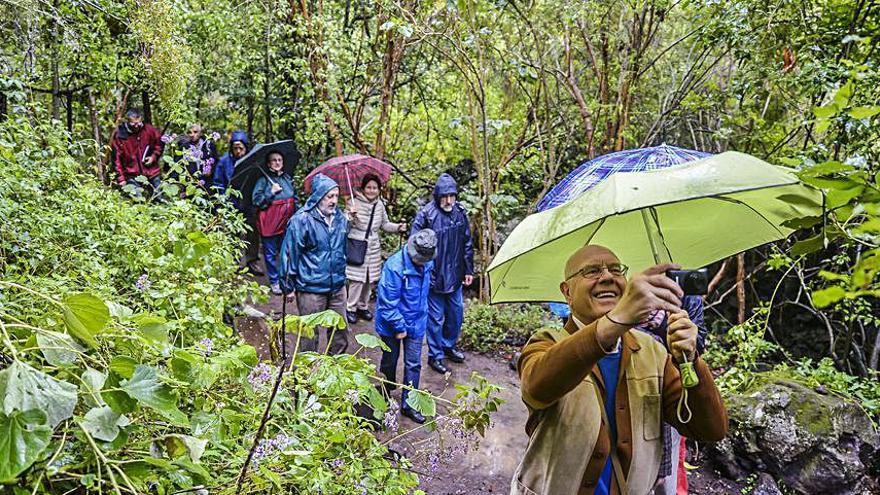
[488, 152, 823, 303]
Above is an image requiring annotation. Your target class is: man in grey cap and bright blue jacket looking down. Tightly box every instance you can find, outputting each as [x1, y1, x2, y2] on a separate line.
[376, 229, 437, 424]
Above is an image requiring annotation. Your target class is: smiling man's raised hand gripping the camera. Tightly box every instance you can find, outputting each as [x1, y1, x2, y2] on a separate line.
[609, 263, 684, 324]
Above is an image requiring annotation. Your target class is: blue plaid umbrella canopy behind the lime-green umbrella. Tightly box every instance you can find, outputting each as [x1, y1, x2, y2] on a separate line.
[535, 144, 712, 211]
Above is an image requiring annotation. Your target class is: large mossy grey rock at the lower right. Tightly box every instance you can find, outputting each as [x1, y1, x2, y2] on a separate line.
[707, 375, 880, 495]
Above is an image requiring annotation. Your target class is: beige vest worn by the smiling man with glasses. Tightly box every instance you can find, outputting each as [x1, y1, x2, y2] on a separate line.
[510, 329, 667, 495]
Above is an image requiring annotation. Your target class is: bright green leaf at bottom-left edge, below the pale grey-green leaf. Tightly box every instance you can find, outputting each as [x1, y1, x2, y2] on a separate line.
[0, 409, 52, 483]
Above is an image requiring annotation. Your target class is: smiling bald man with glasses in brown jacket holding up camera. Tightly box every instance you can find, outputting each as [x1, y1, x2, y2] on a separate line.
[511, 245, 727, 495]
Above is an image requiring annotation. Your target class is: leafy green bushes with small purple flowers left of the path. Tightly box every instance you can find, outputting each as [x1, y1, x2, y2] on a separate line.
[0, 120, 500, 495]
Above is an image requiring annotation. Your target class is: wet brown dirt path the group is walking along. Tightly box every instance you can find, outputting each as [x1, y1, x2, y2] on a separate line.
[237, 286, 749, 495]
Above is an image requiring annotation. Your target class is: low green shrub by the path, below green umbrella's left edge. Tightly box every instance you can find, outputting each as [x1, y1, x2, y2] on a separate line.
[459, 300, 548, 352]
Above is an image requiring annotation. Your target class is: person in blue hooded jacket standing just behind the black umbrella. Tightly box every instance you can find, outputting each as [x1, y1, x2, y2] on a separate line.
[211, 131, 263, 276]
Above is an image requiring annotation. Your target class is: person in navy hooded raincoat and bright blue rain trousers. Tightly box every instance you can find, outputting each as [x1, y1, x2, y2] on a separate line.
[411, 174, 474, 374]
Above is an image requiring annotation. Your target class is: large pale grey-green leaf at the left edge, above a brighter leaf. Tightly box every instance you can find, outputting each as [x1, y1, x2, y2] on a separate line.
[0, 361, 76, 429]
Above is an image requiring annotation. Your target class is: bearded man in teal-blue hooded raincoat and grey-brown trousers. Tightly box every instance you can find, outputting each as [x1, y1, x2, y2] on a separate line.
[280, 174, 348, 356]
